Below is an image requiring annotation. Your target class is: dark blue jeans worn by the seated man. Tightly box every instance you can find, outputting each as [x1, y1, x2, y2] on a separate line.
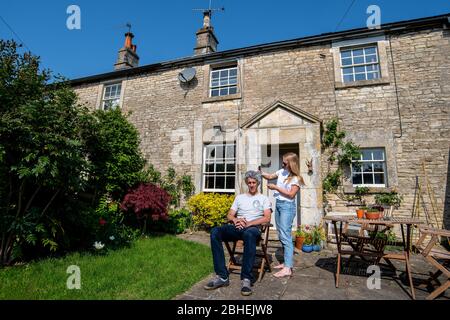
[211, 224, 261, 281]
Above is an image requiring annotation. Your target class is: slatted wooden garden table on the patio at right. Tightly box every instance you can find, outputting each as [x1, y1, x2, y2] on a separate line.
[324, 216, 422, 299]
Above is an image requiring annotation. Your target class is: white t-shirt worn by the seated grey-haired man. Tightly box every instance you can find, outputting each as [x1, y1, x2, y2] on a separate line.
[231, 193, 271, 221]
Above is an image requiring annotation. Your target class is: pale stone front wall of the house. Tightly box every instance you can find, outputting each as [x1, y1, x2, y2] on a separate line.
[76, 29, 450, 228]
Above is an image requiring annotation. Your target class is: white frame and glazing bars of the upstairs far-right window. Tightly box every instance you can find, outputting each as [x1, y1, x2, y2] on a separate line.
[339, 43, 383, 85]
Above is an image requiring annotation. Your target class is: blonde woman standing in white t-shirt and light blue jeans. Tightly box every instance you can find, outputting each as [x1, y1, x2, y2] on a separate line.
[261, 152, 305, 278]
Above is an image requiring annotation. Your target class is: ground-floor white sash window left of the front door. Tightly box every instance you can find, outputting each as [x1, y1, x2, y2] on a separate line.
[203, 143, 236, 193]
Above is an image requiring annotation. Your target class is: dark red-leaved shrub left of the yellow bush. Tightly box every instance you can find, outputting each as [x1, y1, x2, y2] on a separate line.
[120, 183, 170, 221]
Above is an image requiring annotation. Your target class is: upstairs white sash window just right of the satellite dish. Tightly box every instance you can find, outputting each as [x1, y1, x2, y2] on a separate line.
[209, 66, 238, 97]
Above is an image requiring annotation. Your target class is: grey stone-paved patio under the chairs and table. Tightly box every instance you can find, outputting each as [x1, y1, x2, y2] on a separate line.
[175, 232, 450, 300]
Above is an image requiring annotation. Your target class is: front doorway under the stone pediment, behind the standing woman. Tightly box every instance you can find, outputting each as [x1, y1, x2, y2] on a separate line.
[261, 143, 301, 230]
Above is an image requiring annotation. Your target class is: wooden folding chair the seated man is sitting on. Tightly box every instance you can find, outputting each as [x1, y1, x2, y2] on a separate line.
[225, 223, 272, 281]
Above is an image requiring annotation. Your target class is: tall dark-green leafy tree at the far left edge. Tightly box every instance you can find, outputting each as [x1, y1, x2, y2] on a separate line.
[0, 40, 89, 265]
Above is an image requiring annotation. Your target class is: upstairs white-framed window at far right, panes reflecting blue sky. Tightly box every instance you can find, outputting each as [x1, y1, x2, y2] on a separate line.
[340, 45, 381, 83]
